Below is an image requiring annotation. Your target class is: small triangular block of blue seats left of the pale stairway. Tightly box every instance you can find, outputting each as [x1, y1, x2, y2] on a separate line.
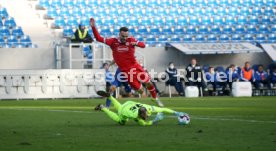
[0, 6, 36, 48]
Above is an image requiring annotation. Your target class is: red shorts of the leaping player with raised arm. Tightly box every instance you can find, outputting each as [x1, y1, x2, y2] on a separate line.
[123, 64, 150, 90]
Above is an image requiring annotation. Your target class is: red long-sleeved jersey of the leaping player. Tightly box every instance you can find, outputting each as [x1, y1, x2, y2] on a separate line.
[92, 27, 145, 71]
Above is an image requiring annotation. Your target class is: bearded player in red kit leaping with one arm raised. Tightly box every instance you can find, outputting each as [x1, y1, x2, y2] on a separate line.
[90, 18, 164, 107]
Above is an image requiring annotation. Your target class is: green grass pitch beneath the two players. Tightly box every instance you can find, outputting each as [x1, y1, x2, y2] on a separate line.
[0, 97, 276, 151]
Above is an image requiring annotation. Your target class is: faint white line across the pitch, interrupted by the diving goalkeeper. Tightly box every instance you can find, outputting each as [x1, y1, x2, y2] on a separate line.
[2, 108, 276, 124]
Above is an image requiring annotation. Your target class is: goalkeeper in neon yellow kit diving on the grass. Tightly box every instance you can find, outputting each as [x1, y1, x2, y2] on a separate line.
[95, 91, 188, 126]
